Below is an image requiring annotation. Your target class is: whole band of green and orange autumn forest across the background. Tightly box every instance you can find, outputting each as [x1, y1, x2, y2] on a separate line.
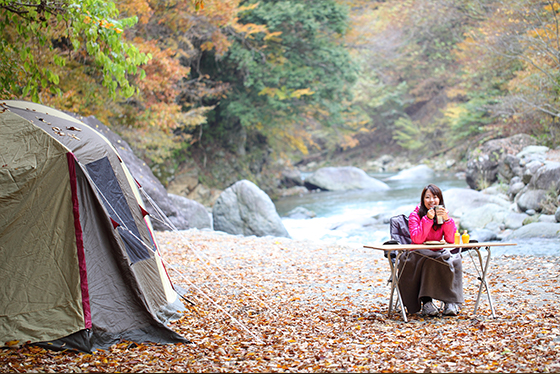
[0, 0, 560, 199]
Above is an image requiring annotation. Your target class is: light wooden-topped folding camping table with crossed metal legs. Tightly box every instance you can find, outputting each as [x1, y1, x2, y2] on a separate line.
[364, 242, 517, 322]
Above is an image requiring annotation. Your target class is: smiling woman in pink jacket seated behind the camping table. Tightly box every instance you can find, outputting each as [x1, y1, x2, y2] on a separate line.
[399, 184, 464, 316]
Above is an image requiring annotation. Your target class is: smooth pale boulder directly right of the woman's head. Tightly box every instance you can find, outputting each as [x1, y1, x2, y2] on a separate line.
[443, 188, 511, 218]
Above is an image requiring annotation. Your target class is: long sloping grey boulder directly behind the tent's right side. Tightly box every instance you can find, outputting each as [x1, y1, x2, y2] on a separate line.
[74, 116, 189, 231]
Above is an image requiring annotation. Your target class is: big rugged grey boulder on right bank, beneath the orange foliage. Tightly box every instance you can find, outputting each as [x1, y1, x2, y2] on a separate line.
[466, 134, 536, 190]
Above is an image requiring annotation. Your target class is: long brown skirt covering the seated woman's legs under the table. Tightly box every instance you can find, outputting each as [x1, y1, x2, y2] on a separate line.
[399, 249, 464, 313]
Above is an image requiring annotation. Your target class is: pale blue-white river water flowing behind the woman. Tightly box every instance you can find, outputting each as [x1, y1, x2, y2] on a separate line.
[275, 174, 560, 256]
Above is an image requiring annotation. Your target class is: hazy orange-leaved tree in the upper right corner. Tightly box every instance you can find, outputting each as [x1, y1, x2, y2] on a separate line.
[447, 0, 560, 145]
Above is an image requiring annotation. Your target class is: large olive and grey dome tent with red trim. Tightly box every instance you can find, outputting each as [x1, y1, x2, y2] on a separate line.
[0, 101, 186, 352]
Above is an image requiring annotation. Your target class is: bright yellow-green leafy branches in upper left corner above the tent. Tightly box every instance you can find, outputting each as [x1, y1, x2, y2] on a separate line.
[0, 0, 150, 102]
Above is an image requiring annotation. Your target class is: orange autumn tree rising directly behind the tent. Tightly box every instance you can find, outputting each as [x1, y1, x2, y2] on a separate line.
[43, 0, 247, 164]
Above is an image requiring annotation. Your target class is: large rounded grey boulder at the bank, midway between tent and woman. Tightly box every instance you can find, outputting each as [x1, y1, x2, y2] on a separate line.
[212, 180, 290, 238]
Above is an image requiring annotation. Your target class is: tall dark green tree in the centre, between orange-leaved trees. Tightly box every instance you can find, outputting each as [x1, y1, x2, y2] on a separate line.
[191, 0, 356, 157]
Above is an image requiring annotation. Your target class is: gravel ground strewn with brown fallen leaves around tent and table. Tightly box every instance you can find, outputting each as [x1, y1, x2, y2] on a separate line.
[0, 230, 560, 372]
